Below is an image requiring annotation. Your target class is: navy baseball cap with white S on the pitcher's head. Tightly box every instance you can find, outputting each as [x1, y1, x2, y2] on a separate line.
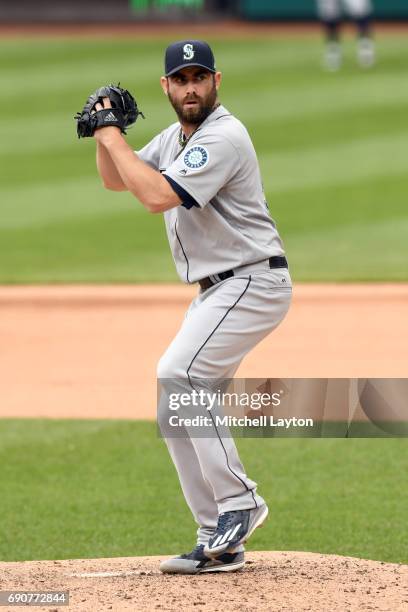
[164, 40, 216, 76]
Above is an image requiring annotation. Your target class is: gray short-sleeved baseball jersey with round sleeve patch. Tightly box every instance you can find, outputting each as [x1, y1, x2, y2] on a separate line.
[137, 106, 284, 283]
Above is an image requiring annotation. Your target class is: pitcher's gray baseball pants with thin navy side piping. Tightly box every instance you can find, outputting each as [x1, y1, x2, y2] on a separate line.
[157, 262, 292, 543]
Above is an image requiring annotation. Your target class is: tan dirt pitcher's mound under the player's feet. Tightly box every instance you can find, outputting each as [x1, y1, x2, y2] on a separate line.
[0, 552, 408, 612]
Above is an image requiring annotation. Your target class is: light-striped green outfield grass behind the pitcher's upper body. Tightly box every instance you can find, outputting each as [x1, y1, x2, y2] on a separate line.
[0, 35, 408, 283]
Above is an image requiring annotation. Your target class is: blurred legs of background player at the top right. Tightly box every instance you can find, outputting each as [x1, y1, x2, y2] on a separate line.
[317, 0, 375, 71]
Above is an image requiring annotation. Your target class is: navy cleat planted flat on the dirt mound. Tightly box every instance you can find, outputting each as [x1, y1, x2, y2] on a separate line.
[160, 544, 245, 574]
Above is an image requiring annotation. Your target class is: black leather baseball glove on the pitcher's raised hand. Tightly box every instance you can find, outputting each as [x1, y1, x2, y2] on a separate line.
[75, 83, 145, 138]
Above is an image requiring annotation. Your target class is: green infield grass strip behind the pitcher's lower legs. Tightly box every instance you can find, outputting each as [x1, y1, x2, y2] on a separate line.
[0, 420, 408, 563]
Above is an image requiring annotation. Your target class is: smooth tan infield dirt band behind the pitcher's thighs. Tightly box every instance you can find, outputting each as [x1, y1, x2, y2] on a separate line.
[0, 284, 408, 419]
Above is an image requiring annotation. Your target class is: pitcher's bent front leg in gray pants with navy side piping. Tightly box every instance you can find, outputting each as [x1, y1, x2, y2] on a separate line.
[158, 270, 291, 513]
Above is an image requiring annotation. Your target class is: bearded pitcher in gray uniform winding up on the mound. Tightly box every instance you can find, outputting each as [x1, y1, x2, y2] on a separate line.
[77, 40, 292, 574]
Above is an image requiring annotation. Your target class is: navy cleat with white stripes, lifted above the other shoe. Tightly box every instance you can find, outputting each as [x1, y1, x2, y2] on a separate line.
[204, 504, 268, 557]
